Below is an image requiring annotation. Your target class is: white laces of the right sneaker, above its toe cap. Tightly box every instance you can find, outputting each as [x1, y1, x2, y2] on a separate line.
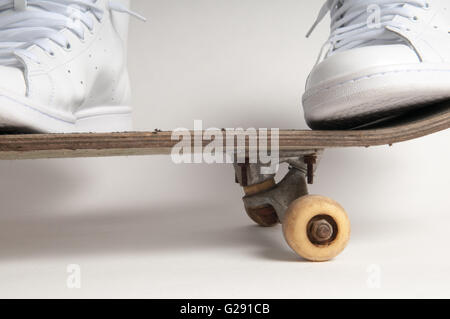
[307, 0, 429, 60]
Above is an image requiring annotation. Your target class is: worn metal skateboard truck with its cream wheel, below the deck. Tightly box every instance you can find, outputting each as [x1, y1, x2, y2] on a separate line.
[234, 150, 350, 261]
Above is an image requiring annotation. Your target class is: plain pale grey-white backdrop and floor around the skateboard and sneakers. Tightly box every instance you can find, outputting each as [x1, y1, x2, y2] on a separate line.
[0, 0, 450, 298]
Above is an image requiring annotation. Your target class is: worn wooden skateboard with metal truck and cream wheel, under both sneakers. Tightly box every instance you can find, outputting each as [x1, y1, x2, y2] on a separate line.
[0, 102, 450, 261]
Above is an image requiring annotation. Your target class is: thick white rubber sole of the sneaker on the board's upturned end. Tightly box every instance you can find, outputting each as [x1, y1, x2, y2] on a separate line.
[303, 64, 450, 129]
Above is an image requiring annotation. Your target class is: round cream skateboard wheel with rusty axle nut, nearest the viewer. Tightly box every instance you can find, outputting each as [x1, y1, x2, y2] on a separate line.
[283, 195, 350, 262]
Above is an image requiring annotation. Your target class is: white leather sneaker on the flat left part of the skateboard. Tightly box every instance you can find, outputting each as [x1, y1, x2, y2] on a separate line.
[0, 0, 141, 132]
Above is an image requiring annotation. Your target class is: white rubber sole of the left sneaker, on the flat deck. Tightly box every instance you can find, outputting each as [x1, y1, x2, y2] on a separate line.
[0, 94, 133, 133]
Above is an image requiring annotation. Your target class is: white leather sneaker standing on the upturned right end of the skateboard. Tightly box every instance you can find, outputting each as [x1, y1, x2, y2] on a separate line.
[303, 0, 450, 129]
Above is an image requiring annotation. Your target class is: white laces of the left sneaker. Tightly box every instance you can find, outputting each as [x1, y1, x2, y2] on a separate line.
[0, 0, 145, 68]
